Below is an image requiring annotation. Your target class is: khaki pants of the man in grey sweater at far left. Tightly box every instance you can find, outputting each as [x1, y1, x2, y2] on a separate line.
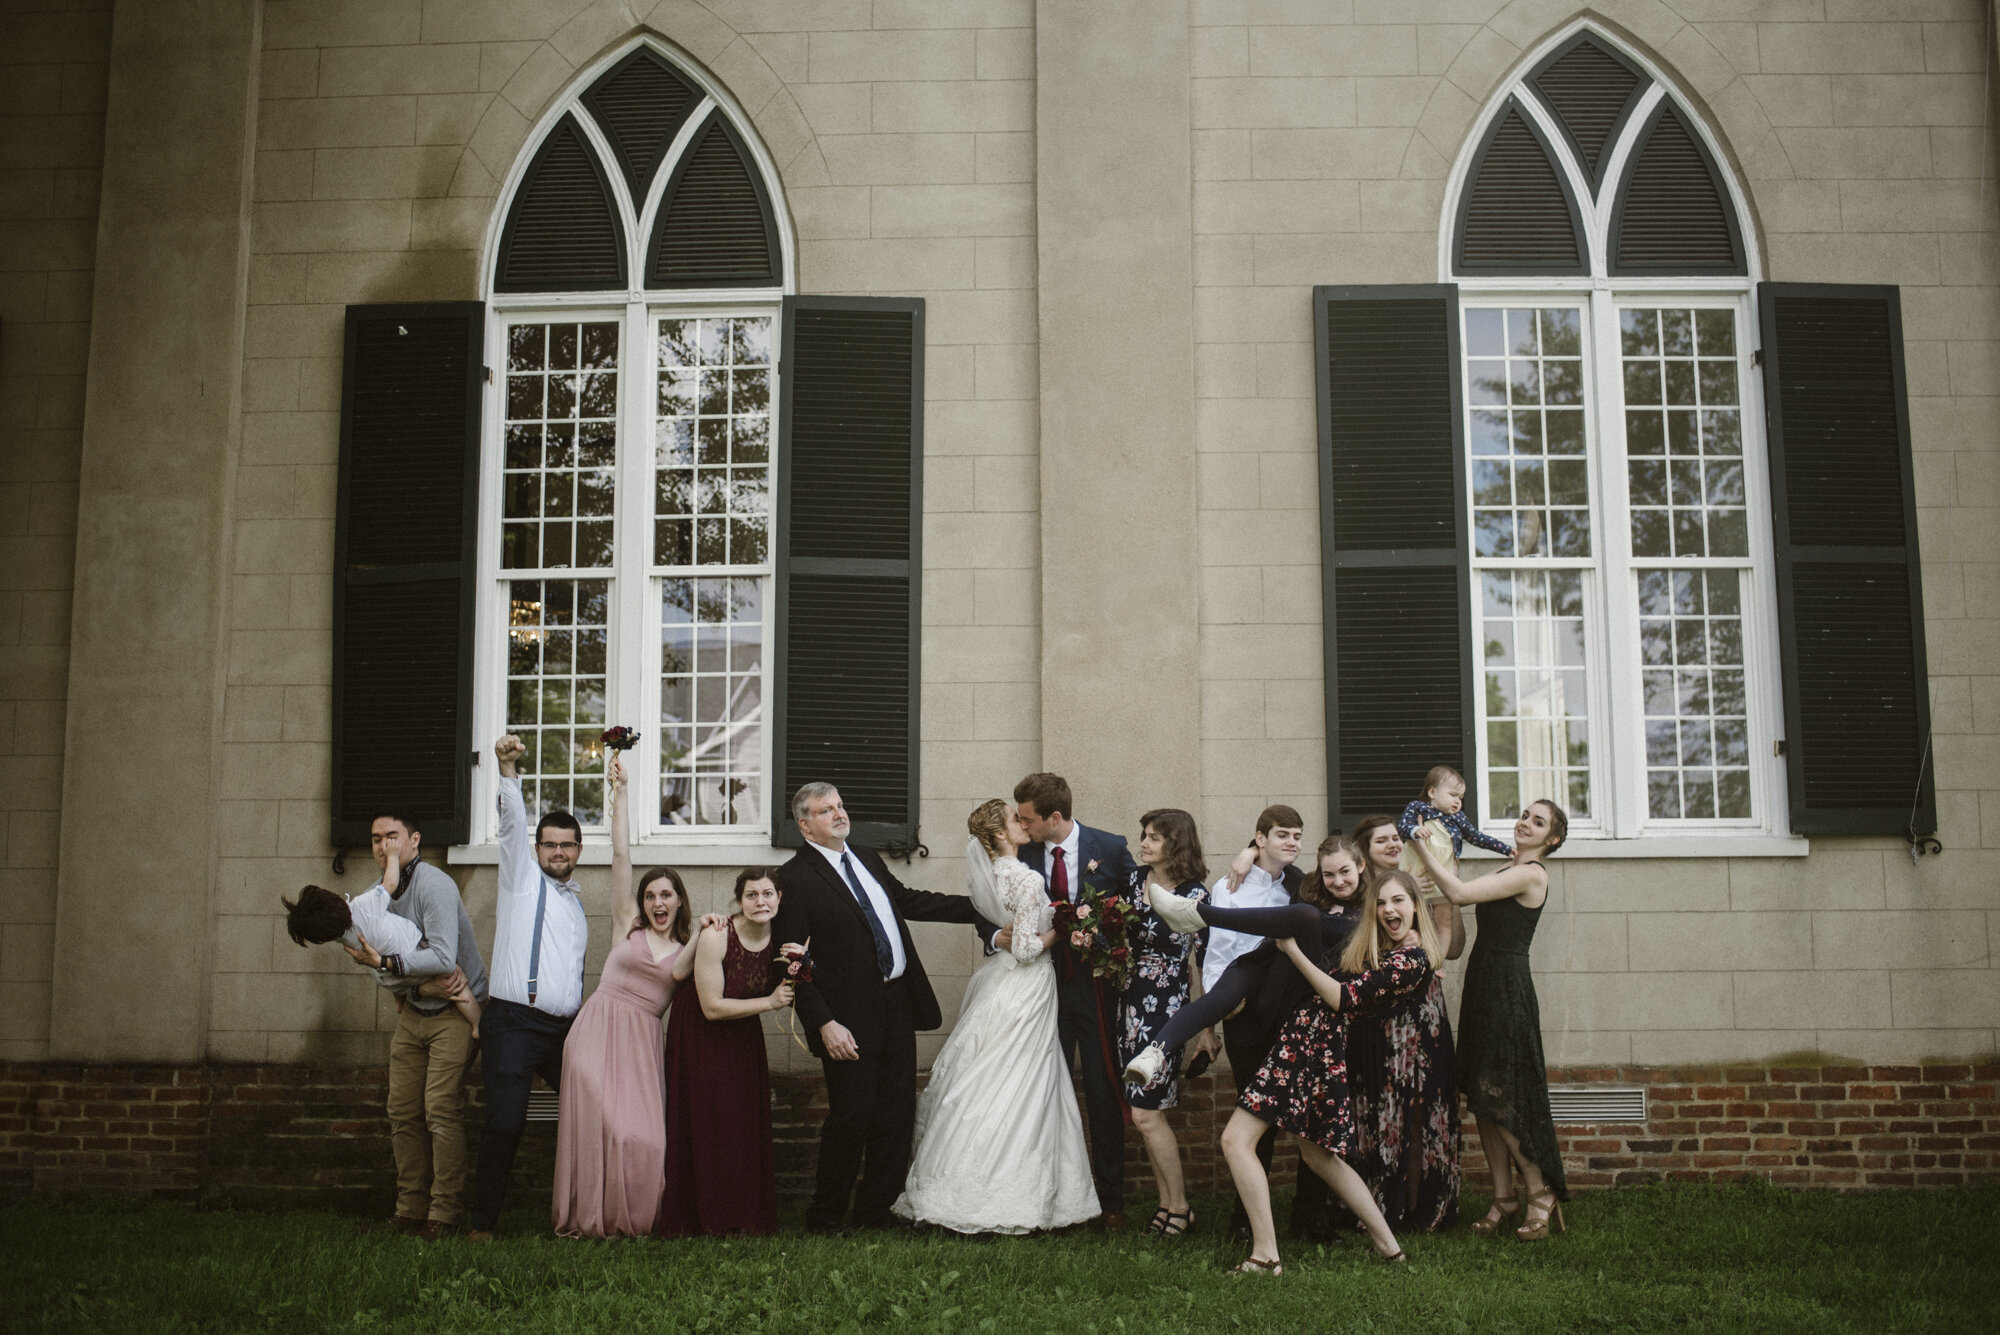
[388, 1005, 472, 1223]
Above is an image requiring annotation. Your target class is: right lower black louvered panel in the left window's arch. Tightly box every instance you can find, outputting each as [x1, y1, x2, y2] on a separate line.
[646, 110, 780, 288]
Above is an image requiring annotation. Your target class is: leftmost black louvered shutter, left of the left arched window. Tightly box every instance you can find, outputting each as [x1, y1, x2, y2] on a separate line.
[332, 302, 486, 847]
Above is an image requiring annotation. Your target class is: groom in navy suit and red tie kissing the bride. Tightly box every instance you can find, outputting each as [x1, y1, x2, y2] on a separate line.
[980, 773, 1138, 1233]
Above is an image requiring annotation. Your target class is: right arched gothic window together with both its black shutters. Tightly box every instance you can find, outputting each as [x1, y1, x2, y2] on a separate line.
[1314, 24, 1936, 853]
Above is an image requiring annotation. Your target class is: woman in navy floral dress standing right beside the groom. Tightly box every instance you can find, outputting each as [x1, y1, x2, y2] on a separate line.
[1118, 807, 1208, 1237]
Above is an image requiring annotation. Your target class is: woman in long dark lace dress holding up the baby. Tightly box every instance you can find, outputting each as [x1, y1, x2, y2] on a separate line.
[1416, 801, 1570, 1243]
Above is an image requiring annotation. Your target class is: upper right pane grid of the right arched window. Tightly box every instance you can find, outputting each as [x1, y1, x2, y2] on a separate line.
[1618, 308, 1750, 560]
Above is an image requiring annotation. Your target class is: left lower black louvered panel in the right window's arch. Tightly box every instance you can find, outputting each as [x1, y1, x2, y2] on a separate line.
[1452, 98, 1590, 274]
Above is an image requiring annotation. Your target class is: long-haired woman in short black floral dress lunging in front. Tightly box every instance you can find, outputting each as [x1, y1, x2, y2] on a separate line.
[1222, 871, 1440, 1273]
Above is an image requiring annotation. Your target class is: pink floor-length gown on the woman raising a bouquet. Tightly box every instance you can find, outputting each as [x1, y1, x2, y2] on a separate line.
[550, 929, 694, 1237]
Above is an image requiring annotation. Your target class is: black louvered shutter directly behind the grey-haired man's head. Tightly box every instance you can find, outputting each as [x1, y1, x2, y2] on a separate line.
[772, 296, 924, 849]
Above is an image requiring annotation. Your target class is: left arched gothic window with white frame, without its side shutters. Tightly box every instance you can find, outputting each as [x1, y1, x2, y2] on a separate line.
[480, 42, 790, 837]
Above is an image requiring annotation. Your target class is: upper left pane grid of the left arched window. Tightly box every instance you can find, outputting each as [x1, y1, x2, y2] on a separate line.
[500, 322, 618, 570]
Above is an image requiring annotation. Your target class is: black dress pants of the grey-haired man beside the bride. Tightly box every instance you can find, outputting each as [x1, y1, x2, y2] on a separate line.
[806, 977, 916, 1229]
